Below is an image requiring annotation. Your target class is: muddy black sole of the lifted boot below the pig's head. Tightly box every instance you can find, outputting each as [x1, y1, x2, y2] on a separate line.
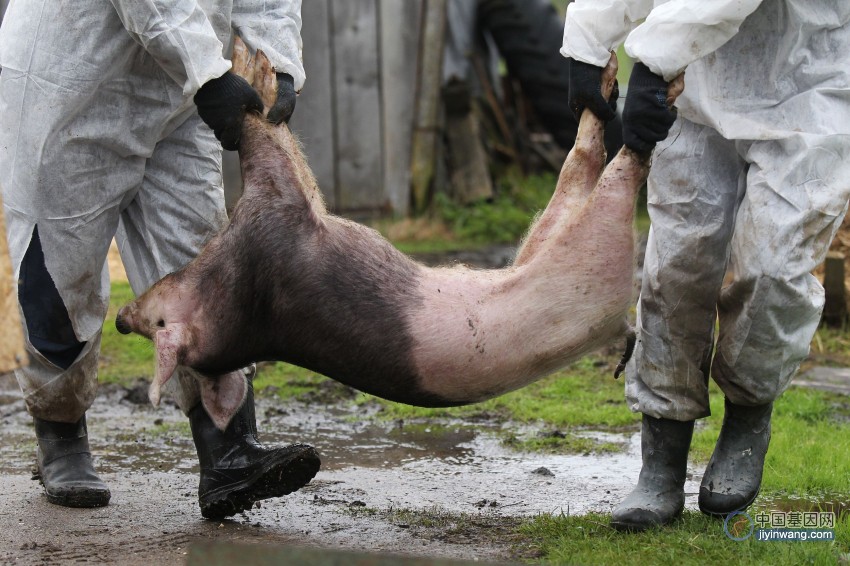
[199, 447, 321, 520]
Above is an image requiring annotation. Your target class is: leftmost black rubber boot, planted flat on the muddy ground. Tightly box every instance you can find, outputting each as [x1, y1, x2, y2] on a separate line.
[33, 415, 110, 507]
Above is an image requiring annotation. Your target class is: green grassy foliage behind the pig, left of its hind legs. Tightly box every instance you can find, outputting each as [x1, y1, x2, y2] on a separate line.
[435, 174, 558, 243]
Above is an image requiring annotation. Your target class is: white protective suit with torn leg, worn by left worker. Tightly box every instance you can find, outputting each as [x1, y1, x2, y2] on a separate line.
[0, 0, 305, 422]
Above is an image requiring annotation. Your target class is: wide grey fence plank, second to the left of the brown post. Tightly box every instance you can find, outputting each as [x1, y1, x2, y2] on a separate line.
[331, 0, 380, 214]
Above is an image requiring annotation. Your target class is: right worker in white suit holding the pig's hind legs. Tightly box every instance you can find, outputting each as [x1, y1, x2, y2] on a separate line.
[561, 0, 850, 530]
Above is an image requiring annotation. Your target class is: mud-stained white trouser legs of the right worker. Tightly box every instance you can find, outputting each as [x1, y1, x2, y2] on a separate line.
[626, 118, 850, 421]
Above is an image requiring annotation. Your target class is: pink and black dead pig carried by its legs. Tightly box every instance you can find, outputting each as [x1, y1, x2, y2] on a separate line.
[116, 42, 676, 427]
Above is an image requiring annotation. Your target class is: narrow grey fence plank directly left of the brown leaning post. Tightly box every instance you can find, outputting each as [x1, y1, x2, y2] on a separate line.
[379, 0, 424, 216]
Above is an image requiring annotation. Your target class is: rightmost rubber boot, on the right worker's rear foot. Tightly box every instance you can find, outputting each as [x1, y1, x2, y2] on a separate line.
[699, 399, 773, 516]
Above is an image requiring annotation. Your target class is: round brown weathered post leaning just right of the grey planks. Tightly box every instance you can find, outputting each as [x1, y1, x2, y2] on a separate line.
[410, 0, 447, 213]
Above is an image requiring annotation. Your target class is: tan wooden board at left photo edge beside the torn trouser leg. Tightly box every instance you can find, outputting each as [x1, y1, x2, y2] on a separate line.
[0, 199, 26, 372]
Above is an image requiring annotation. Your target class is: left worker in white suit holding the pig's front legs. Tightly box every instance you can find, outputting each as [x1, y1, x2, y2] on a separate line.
[0, 0, 319, 519]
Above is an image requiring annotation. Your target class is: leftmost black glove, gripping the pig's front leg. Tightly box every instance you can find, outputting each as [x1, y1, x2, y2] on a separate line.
[195, 71, 263, 151]
